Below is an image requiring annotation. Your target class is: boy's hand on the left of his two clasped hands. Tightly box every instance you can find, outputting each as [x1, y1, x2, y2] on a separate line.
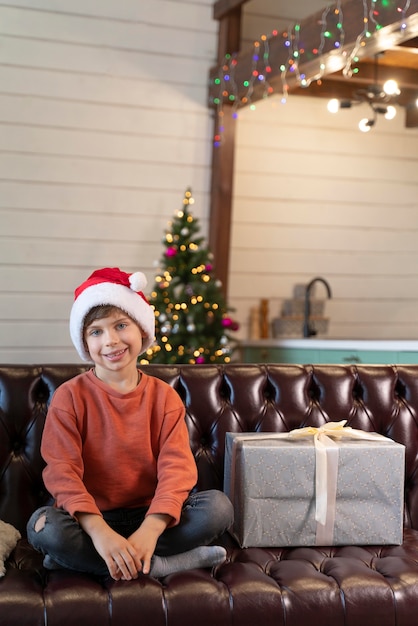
[77, 513, 142, 580]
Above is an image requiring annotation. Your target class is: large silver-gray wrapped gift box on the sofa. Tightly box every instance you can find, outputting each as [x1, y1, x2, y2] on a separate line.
[224, 429, 405, 547]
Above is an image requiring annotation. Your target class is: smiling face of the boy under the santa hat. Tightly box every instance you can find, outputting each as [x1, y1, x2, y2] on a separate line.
[84, 309, 142, 370]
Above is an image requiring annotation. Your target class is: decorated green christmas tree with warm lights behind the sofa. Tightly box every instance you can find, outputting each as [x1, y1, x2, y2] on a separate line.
[141, 189, 238, 363]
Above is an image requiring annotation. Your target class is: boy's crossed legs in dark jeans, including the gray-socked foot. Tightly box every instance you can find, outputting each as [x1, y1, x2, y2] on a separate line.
[27, 490, 233, 578]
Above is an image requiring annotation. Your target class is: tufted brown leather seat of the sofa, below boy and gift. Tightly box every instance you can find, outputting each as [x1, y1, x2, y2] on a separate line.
[4, 529, 418, 626]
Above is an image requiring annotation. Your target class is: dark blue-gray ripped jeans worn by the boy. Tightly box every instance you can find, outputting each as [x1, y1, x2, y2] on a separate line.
[27, 490, 233, 576]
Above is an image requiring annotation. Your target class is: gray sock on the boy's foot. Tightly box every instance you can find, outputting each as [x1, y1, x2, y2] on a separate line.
[150, 546, 226, 578]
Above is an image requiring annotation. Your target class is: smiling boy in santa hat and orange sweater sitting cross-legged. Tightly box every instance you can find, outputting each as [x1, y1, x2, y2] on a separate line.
[28, 268, 233, 580]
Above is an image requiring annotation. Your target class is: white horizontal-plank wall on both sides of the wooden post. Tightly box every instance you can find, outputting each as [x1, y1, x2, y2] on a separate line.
[0, 0, 418, 363]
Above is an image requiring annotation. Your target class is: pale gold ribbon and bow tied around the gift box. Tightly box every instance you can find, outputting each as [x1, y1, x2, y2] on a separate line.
[288, 420, 385, 545]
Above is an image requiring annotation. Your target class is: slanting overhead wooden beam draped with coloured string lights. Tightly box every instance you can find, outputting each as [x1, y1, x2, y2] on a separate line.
[209, 0, 418, 106]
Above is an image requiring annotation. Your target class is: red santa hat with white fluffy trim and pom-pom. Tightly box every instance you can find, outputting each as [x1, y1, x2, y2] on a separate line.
[70, 267, 155, 361]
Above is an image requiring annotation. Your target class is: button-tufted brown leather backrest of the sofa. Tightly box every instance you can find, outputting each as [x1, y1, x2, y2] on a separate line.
[0, 364, 418, 532]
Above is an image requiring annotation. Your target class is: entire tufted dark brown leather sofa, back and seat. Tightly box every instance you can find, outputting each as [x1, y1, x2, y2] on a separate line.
[0, 364, 418, 626]
